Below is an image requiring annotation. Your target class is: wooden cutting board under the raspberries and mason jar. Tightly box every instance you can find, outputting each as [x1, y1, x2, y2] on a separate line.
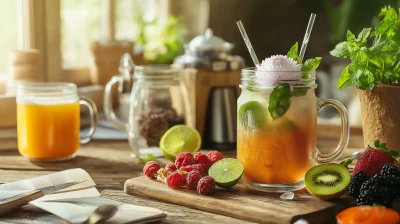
[124, 176, 355, 224]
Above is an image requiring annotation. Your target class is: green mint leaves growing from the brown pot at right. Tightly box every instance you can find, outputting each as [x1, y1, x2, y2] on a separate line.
[330, 7, 400, 90]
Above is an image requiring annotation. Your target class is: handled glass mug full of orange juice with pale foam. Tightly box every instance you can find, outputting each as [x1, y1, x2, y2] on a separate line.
[17, 83, 97, 161]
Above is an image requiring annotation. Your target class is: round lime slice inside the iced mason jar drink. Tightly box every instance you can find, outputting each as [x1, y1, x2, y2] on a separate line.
[238, 101, 267, 129]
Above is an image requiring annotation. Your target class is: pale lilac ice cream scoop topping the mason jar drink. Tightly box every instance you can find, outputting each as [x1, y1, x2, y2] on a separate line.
[256, 55, 302, 86]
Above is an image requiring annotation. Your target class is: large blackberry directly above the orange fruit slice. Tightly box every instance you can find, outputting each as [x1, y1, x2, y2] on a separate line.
[357, 183, 394, 208]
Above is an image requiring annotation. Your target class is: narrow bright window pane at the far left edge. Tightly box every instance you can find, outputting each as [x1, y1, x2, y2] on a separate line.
[0, 0, 19, 76]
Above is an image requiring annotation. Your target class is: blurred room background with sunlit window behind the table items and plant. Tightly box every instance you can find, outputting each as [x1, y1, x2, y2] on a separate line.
[0, 0, 400, 150]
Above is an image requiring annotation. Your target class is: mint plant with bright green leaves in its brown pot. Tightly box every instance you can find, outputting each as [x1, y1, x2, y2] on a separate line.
[330, 7, 400, 151]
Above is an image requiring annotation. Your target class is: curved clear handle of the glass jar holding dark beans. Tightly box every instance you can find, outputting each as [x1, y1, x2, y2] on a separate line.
[103, 76, 128, 132]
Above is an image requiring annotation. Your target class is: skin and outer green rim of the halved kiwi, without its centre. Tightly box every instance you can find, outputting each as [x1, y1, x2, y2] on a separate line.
[304, 163, 351, 201]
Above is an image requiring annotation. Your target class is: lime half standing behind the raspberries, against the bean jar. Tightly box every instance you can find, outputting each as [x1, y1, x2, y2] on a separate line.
[160, 125, 201, 161]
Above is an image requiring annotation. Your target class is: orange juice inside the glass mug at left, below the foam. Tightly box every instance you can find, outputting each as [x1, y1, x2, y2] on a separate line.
[17, 102, 80, 159]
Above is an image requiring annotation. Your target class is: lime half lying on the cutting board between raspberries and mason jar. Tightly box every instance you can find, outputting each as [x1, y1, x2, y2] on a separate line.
[208, 158, 244, 188]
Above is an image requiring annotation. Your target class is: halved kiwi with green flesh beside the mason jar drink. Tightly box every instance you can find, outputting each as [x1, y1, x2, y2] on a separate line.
[304, 163, 351, 200]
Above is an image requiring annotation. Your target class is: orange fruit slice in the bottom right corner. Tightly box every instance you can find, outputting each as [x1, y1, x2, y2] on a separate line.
[336, 206, 400, 224]
